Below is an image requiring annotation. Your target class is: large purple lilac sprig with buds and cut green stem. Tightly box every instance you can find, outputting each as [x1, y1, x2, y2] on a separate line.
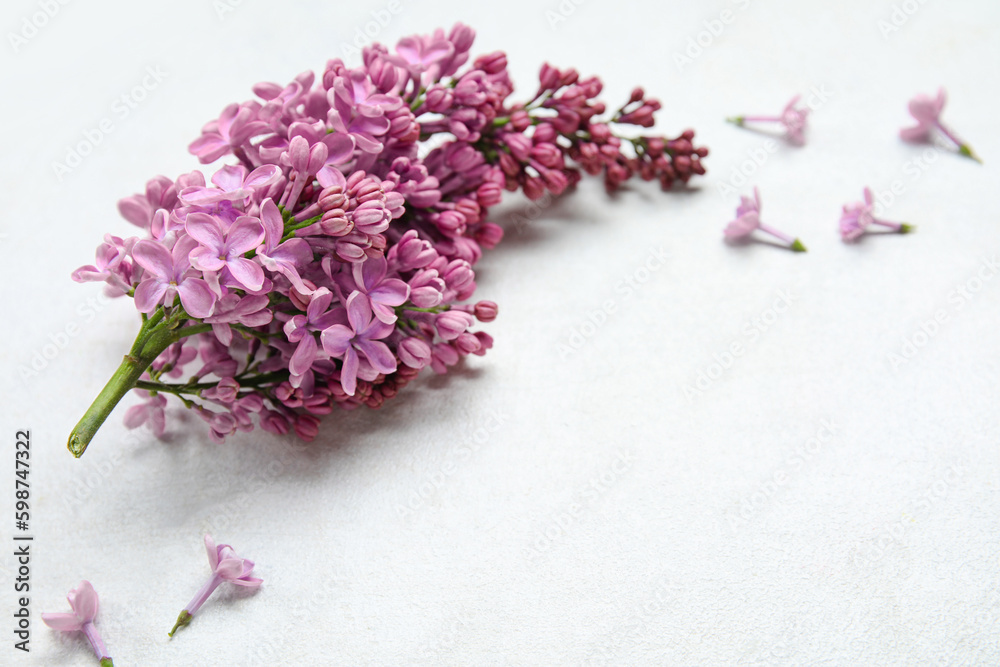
[70, 24, 708, 456]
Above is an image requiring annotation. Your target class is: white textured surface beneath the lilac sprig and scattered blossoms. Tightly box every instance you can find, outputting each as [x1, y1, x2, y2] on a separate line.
[0, 0, 1000, 666]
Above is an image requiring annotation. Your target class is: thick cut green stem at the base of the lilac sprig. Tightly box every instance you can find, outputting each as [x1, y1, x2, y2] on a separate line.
[66, 316, 212, 458]
